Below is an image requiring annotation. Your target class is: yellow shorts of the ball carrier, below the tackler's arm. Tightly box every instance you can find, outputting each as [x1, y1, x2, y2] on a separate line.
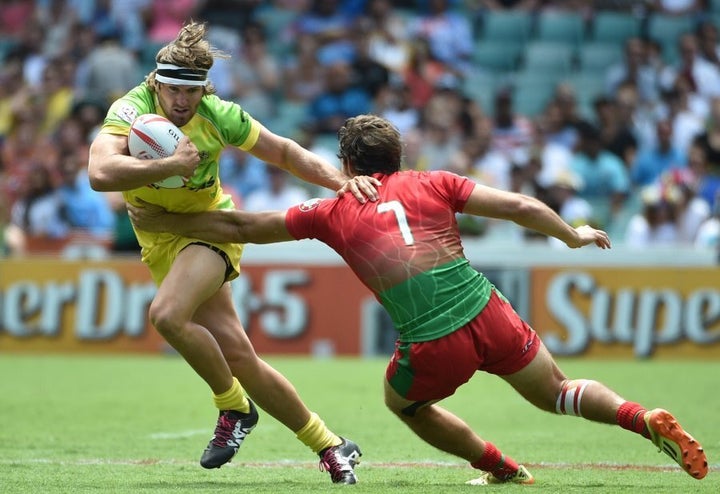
[140, 232, 245, 285]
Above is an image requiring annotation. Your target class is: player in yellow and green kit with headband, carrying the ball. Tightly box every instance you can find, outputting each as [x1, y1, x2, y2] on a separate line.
[88, 22, 379, 484]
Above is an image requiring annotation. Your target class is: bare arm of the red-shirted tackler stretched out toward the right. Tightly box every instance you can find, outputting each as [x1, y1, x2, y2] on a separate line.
[463, 185, 610, 249]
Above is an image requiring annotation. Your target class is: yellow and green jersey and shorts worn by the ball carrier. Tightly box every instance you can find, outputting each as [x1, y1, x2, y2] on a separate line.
[100, 82, 260, 283]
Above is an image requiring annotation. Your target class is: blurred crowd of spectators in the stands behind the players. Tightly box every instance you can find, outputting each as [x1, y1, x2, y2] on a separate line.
[0, 0, 720, 257]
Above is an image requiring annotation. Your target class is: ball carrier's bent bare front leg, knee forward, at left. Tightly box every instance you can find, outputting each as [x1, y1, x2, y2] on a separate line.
[149, 245, 232, 394]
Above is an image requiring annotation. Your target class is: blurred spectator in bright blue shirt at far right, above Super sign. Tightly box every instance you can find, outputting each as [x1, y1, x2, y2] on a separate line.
[630, 120, 686, 186]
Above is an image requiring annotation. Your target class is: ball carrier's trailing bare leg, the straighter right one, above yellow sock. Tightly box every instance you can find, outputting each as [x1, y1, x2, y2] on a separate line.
[193, 282, 310, 432]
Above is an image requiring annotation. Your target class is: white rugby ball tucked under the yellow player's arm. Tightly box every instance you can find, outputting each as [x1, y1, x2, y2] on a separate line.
[128, 113, 185, 189]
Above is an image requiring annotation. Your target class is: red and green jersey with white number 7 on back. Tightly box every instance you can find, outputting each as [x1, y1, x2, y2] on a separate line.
[285, 171, 492, 342]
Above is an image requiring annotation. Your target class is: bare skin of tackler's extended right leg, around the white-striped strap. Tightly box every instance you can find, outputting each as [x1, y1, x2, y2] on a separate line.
[500, 344, 625, 424]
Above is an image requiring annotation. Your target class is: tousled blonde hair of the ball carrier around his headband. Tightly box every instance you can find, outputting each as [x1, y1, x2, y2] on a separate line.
[145, 21, 230, 94]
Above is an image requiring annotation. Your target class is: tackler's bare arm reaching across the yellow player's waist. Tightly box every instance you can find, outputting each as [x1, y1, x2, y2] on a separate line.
[127, 201, 295, 244]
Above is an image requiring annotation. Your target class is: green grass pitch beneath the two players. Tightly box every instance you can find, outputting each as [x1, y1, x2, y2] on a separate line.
[0, 353, 720, 494]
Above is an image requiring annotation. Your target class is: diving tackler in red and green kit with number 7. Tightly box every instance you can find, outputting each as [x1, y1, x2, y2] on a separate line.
[129, 115, 708, 484]
